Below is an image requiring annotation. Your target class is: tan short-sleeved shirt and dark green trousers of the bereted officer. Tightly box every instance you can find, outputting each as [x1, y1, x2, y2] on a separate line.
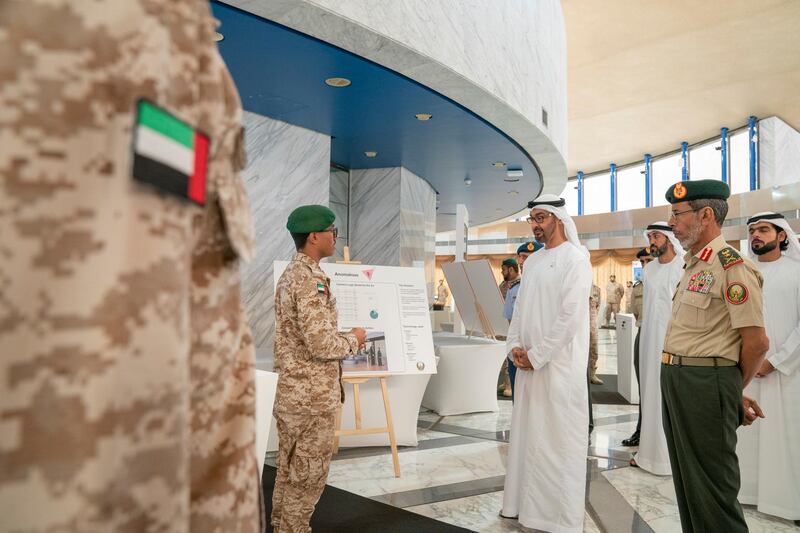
[661, 236, 764, 533]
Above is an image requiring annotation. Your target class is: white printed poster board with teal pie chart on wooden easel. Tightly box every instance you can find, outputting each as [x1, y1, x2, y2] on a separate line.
[274, 261, 436, 376]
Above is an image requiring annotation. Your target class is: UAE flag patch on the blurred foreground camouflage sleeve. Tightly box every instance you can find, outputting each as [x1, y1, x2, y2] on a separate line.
[133, 99, 209, 205]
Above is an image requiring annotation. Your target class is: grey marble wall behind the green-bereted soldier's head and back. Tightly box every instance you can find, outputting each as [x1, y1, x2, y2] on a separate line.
[242, 112, 331, 364]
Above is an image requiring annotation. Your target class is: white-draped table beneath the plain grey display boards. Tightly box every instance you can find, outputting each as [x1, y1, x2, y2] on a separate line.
[422, 333, 506, 416]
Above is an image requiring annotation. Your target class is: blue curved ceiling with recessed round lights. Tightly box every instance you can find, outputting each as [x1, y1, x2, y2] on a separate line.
[212, 2, 542, 225]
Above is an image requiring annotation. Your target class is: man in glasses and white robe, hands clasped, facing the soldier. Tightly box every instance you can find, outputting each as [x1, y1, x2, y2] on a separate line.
[500, 194, 592, 533]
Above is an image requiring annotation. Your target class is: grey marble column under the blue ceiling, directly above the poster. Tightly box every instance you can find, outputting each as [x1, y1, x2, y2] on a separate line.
[349, 167, 436, 292]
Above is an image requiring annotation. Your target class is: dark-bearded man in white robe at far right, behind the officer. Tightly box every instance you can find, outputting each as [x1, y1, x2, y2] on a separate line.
[736, 212, 800, 525]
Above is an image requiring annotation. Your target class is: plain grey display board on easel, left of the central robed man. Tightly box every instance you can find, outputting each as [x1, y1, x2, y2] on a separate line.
[442, 259, 508, 335]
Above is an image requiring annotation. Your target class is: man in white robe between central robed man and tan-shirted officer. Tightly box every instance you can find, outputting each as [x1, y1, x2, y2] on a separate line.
[631, 221, 685, 476]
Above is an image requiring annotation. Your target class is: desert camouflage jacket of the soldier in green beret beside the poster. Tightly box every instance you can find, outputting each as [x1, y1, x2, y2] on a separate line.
[274, 252, 358, 416]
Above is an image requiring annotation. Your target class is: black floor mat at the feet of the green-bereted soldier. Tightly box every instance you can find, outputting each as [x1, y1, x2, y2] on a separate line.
[261, 465, 470, 533]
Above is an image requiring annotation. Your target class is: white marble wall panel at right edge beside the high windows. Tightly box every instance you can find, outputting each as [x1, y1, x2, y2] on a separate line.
[758, 117, 800, 189]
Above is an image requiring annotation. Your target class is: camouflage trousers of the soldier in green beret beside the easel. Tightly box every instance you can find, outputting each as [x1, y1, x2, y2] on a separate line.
[271, 411, 336, 533]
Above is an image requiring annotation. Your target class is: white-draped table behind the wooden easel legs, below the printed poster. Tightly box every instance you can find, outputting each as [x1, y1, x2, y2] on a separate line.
[267, 374, 431, 451]
